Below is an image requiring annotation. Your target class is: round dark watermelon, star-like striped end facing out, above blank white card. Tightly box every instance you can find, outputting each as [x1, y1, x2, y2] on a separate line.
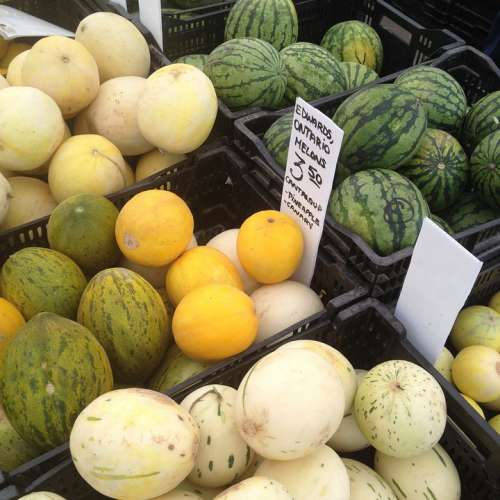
[398, 128, 469, 212]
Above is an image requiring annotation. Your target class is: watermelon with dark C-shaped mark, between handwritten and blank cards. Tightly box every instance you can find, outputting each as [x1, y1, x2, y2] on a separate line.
[329, 169, 430, 255]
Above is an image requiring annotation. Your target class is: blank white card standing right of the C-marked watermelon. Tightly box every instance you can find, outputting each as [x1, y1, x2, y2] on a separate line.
[395, 218, 483, 364]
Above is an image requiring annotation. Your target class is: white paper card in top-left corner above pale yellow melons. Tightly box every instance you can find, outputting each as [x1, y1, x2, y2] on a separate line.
[0, 5, 74, 40]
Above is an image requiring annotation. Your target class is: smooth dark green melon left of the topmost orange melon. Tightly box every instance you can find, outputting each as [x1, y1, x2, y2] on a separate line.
[47, 193, 121, 276]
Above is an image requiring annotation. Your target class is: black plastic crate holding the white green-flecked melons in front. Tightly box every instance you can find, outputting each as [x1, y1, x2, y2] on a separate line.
[0, 299, 499, 500]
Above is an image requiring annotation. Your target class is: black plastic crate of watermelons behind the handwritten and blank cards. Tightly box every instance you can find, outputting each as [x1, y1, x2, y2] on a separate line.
[234, 46, 500, 301]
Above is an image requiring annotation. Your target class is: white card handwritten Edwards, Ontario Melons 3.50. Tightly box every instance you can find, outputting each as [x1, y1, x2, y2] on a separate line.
[281, 97, 344, 285]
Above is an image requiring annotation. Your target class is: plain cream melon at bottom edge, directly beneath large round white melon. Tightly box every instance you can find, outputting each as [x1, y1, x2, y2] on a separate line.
[256, 445, 350, 500]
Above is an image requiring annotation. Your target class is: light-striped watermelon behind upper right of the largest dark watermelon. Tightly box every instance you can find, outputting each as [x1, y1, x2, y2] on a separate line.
[395, 66, 467, 133]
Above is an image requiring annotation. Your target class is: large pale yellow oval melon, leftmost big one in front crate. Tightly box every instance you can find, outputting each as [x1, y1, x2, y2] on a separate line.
[70, 389, 200, 500]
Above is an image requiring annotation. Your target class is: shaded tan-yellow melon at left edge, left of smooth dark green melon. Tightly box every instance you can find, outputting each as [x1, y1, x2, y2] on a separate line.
[0, 177, 57, 231]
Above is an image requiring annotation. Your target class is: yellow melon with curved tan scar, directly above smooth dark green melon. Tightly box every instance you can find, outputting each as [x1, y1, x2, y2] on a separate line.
[49, 134, 130, 203]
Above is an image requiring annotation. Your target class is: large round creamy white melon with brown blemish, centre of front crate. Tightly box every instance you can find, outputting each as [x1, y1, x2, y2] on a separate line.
[236, 349, 345, 460]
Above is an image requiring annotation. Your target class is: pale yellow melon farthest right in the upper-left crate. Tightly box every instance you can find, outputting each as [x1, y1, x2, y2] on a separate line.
[137, 64, 217, 154]
